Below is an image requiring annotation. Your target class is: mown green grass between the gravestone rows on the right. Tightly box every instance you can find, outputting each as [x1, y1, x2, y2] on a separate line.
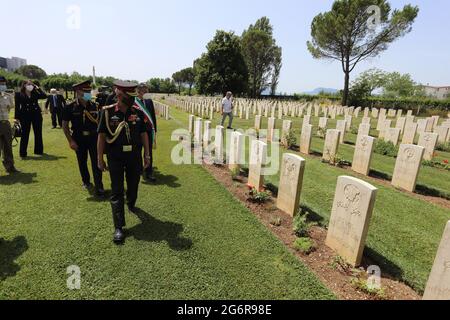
[168, 103, 450, 292]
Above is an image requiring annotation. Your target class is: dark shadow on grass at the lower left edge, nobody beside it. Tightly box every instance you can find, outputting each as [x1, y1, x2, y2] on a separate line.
[0, 236, 28, 281]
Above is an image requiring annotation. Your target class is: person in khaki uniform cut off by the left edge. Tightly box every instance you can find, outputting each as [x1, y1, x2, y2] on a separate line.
[0, 76, 18, 174]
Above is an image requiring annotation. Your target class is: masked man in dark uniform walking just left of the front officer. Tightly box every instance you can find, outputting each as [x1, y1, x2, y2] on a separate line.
[63, 80, 105, 197]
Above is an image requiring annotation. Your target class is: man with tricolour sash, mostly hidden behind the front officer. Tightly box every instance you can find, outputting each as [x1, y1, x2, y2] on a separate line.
[135, 83, 157, 182]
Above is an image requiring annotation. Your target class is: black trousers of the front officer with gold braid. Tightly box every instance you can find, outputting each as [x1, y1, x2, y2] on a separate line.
[107, 148, 142, 229]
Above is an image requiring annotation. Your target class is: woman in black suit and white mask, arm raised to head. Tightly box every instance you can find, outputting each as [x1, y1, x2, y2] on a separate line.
[14, 80, 47, 159]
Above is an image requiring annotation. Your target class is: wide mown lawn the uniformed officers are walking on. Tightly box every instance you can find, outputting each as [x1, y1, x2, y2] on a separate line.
[0, 112, 334, 299]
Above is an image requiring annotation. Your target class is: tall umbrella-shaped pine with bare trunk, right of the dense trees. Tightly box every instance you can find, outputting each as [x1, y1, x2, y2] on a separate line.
[307, 0, 419, 105]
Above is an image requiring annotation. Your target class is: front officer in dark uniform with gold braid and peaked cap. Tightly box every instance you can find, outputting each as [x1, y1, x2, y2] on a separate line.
[98, 81, 150, 244]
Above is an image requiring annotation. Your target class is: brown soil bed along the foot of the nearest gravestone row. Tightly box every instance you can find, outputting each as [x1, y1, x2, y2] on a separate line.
[204, 164, 421, 300]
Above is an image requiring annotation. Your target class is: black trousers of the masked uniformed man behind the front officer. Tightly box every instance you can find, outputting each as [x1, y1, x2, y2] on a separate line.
[73, 133, 103, 190]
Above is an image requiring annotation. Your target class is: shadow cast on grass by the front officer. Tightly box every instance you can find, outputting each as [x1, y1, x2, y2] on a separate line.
[127, 208, 192, 251]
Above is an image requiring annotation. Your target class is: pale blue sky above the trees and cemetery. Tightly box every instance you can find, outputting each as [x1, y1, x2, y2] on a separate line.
[0, 0, 450, 93]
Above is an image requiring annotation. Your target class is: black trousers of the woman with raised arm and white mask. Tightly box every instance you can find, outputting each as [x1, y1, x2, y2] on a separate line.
[19, 112, 44, 158]
